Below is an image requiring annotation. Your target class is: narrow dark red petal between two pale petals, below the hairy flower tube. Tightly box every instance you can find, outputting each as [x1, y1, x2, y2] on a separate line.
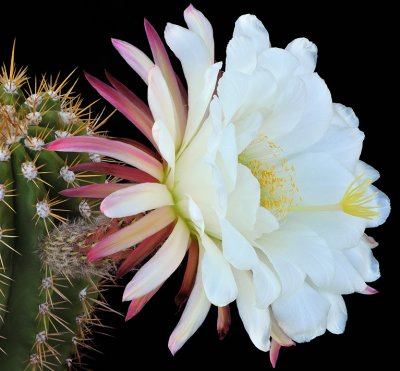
[116, 224, 173, 278]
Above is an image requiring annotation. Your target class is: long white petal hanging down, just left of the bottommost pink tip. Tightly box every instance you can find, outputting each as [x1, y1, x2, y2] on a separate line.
[235, 270, 270, 352]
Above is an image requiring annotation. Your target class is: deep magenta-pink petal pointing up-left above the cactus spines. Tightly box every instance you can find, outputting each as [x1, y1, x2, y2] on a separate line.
[85, 73, 154, 144]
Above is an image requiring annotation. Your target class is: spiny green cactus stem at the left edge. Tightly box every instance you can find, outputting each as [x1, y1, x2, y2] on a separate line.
[0, 52, 106, 371]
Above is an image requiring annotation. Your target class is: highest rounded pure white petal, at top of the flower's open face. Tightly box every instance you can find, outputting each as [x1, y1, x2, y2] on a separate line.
[233, 14, 270, 53]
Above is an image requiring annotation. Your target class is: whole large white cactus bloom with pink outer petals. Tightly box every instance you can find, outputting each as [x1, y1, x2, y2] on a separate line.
[47, 6, 389, 364]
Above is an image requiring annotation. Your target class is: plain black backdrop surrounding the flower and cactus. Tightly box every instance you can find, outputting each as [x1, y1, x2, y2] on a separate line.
[0, 0, 399, 371]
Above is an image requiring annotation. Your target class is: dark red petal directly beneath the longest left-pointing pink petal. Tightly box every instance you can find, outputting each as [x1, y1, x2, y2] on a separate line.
[70, 162, 157, 183]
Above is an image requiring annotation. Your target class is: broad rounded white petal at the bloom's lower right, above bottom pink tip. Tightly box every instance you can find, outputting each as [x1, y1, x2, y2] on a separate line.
[272, 283, 330, 343]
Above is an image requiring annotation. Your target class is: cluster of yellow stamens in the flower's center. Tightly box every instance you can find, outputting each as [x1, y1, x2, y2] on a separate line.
[239, 136, 298, 220]
